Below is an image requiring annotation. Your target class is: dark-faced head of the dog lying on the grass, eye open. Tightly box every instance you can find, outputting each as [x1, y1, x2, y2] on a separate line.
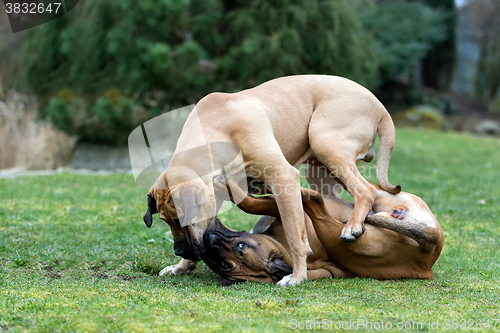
[202, 228, 292, 285]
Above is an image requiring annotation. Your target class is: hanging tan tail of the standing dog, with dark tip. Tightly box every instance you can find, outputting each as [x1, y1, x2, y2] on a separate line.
[377, 108, 401, 194]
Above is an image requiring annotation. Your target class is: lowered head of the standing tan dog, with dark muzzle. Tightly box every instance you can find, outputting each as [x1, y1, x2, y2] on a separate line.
[144, 172, 213, 261]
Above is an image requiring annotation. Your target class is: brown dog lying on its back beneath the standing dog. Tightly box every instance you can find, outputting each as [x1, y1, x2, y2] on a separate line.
[203, 178, 444, 284]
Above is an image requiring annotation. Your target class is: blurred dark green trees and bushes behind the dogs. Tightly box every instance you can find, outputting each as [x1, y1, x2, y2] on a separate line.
[0, 0, 456, 145]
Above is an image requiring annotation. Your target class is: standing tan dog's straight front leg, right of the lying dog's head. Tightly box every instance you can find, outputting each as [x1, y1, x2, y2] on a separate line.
[271, 168, 311, 287]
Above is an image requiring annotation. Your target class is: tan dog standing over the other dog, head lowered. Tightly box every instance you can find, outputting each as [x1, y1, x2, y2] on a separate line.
[144, 75, 401, 286]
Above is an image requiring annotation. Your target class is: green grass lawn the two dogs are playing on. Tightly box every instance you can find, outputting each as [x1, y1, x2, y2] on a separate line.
[0, 129, 500, 332]
